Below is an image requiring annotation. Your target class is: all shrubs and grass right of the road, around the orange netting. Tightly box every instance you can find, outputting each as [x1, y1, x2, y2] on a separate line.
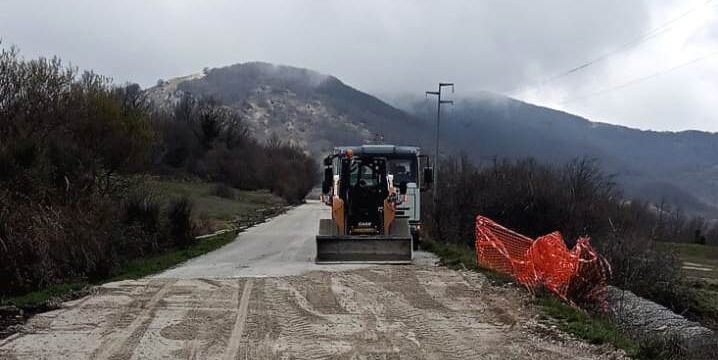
[423, 156, 718, 358]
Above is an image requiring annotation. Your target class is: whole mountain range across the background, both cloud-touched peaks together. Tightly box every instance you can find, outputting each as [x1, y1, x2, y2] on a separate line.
[146, 62, 718, 218]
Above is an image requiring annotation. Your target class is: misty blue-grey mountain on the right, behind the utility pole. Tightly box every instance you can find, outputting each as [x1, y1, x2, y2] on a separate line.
[398, 93, 718, 218]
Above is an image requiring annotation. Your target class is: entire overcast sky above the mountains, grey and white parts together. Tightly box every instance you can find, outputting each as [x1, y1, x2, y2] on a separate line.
[0, 0, 718, 131]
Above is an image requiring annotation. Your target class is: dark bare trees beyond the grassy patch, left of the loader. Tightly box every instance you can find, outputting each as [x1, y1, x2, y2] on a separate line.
[155, 95, 319, 203]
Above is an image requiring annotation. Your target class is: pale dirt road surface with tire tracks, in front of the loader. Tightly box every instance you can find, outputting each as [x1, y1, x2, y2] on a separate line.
[0, 203, 615, 359]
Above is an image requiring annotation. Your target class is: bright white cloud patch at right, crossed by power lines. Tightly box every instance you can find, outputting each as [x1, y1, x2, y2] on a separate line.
[521, 0, 718, 131]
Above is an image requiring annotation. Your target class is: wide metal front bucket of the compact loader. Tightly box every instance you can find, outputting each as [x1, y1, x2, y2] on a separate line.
[316, 219, 413, 264]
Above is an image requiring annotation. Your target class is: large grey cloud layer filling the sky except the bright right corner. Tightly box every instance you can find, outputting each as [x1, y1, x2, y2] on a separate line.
[0, 0, 716, 131]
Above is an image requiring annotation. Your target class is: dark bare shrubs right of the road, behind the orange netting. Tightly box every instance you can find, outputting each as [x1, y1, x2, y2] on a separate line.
[422, 156, 715, 326]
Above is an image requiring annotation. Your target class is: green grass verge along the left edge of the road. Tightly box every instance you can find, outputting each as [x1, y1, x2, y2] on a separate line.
[0, 179, 287, 337]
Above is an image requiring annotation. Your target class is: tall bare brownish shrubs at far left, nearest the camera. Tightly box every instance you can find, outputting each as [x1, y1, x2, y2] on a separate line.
[0, 49, 159, 296]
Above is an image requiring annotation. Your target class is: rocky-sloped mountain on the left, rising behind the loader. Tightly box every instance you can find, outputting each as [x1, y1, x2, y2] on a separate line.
[147, 62, 426, 156]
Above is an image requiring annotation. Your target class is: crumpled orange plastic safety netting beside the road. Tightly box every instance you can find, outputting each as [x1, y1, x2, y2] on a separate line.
[476, 216, 611, 306]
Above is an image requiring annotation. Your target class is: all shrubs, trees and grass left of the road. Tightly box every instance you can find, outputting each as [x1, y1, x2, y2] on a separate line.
[0, 48, 317, 303]
